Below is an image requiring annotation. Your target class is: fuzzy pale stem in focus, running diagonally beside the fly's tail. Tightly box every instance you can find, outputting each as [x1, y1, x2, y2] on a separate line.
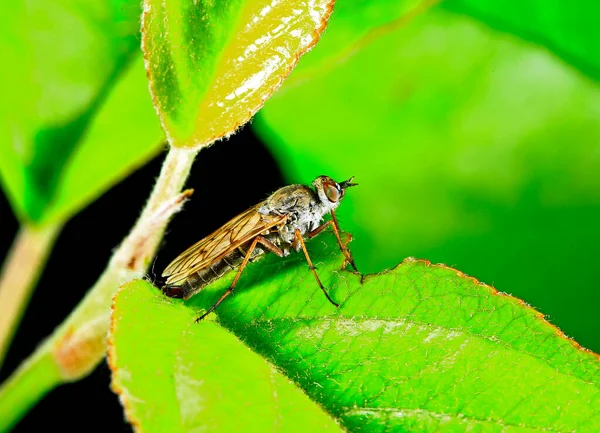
[0, 148, 196, 432]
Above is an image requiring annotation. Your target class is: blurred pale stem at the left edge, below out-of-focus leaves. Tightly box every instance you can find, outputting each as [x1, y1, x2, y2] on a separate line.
[0, 224, 62, 368]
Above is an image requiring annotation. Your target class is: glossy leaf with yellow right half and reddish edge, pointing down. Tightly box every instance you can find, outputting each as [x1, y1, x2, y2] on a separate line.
[143, 0, 333, 147]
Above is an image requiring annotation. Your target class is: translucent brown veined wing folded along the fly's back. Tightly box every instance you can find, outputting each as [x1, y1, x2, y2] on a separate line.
[162, 202, 287, 284]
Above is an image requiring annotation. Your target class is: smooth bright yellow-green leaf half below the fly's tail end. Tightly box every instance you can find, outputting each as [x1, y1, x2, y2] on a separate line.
[109, 281, 340, 432]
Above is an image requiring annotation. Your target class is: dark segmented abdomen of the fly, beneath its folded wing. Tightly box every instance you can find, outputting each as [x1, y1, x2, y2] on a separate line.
[162, 248, 264, 299]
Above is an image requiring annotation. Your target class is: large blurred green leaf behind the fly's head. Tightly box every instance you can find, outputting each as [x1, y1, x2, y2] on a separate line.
[254, 1, 600, 351]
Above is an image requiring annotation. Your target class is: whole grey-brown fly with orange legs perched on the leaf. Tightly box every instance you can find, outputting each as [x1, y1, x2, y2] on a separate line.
[162, 176, 356, 321]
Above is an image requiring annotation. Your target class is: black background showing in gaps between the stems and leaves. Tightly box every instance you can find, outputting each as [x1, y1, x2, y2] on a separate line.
[0, 127, 284, 432]
